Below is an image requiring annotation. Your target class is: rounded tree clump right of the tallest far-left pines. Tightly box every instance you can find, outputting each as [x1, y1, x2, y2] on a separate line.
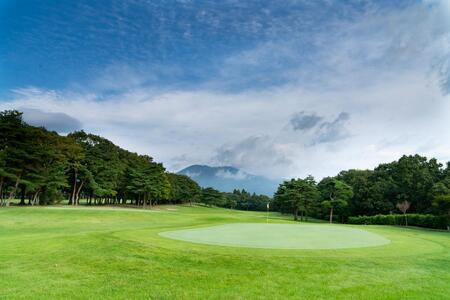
[69, 131, 171, 207]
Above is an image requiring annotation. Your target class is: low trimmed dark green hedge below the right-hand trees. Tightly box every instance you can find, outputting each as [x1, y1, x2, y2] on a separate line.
[348, 214, 449, 229]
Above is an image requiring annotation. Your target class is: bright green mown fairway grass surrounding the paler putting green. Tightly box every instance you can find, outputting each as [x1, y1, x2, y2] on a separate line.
[0, 206, 450, 299]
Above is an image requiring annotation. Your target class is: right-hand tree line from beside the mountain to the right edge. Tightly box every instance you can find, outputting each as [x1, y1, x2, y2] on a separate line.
[274, 155, 450, 222]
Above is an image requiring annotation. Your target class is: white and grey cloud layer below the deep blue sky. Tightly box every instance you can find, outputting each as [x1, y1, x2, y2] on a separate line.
[0, 1, 450, 182]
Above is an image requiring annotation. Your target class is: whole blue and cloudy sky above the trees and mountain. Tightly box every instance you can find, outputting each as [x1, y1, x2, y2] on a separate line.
[0, 0, 450, 177]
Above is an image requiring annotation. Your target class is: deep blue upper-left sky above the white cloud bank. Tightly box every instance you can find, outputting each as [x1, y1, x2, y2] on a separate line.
[0, 0, 420, 91]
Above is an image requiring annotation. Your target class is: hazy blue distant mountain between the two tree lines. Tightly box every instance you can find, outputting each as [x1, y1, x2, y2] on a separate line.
[178, 165, 280, 196]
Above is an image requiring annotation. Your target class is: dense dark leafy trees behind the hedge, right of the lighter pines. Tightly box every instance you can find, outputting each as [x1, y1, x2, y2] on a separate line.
[318, 155, 450, 221]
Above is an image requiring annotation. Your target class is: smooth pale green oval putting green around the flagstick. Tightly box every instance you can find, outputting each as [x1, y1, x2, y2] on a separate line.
[160, 223, 390, 249]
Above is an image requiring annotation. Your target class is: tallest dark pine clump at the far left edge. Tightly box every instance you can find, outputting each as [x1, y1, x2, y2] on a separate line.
[0, 111, 72, 205]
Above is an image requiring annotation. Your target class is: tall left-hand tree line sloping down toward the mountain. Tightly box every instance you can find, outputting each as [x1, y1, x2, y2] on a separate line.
[0, 110, 201, 207]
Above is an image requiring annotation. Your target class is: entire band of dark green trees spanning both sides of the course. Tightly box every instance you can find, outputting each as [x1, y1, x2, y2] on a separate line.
[0, 111, 450, 226]
